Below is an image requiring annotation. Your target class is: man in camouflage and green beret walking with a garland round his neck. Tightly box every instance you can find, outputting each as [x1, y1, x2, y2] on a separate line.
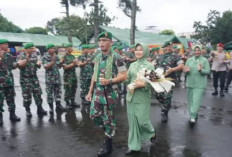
[86, 32, 126, 157]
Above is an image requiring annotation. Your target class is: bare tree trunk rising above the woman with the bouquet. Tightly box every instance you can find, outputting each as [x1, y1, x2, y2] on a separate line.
[130, 0, 137, 45]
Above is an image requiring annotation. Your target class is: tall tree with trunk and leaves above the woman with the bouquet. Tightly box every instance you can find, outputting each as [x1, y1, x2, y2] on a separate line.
[118, 0, 141, 45]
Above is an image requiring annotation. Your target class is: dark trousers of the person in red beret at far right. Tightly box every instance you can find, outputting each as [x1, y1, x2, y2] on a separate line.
[213, 71, 226, 90]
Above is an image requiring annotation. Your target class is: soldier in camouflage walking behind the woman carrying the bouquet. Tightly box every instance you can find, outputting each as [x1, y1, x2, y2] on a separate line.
[156, 42, 184, 122]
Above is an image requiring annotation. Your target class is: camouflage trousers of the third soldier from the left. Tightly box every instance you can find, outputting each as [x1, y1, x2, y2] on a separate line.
[46, 84, 61, 104]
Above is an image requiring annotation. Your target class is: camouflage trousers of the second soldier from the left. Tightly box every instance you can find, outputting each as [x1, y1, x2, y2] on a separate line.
[21, 80, 43, 107]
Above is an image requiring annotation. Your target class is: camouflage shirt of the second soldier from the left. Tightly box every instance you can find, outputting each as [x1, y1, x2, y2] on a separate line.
[17, 54, 40, 83]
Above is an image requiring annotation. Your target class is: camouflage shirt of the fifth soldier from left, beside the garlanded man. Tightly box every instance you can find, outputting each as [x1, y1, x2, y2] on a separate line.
[78, 54, 93, 79]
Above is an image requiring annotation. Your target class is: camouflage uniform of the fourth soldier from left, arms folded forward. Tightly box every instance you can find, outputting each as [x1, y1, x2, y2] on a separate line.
[63, 53, 77, 103]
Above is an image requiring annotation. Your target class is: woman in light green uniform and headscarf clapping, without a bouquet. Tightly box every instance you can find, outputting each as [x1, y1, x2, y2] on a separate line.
[184, 45, 210, 124]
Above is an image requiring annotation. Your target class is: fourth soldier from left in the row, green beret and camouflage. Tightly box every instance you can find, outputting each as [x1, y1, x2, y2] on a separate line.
[61, 43, 80, 109]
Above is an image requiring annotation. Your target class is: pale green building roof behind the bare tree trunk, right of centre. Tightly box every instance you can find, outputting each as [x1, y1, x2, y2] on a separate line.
[100, 26, 188, 48]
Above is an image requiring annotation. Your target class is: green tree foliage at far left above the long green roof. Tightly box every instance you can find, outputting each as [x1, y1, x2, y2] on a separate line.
[0, 13, 23, 33]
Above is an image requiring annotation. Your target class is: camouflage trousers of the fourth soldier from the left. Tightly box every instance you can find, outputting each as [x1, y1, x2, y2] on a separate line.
[64, 81, 77, 101]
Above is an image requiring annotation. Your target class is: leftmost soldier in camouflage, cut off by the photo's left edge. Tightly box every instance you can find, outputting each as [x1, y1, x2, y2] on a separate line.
[0, 39, 20, 125]
